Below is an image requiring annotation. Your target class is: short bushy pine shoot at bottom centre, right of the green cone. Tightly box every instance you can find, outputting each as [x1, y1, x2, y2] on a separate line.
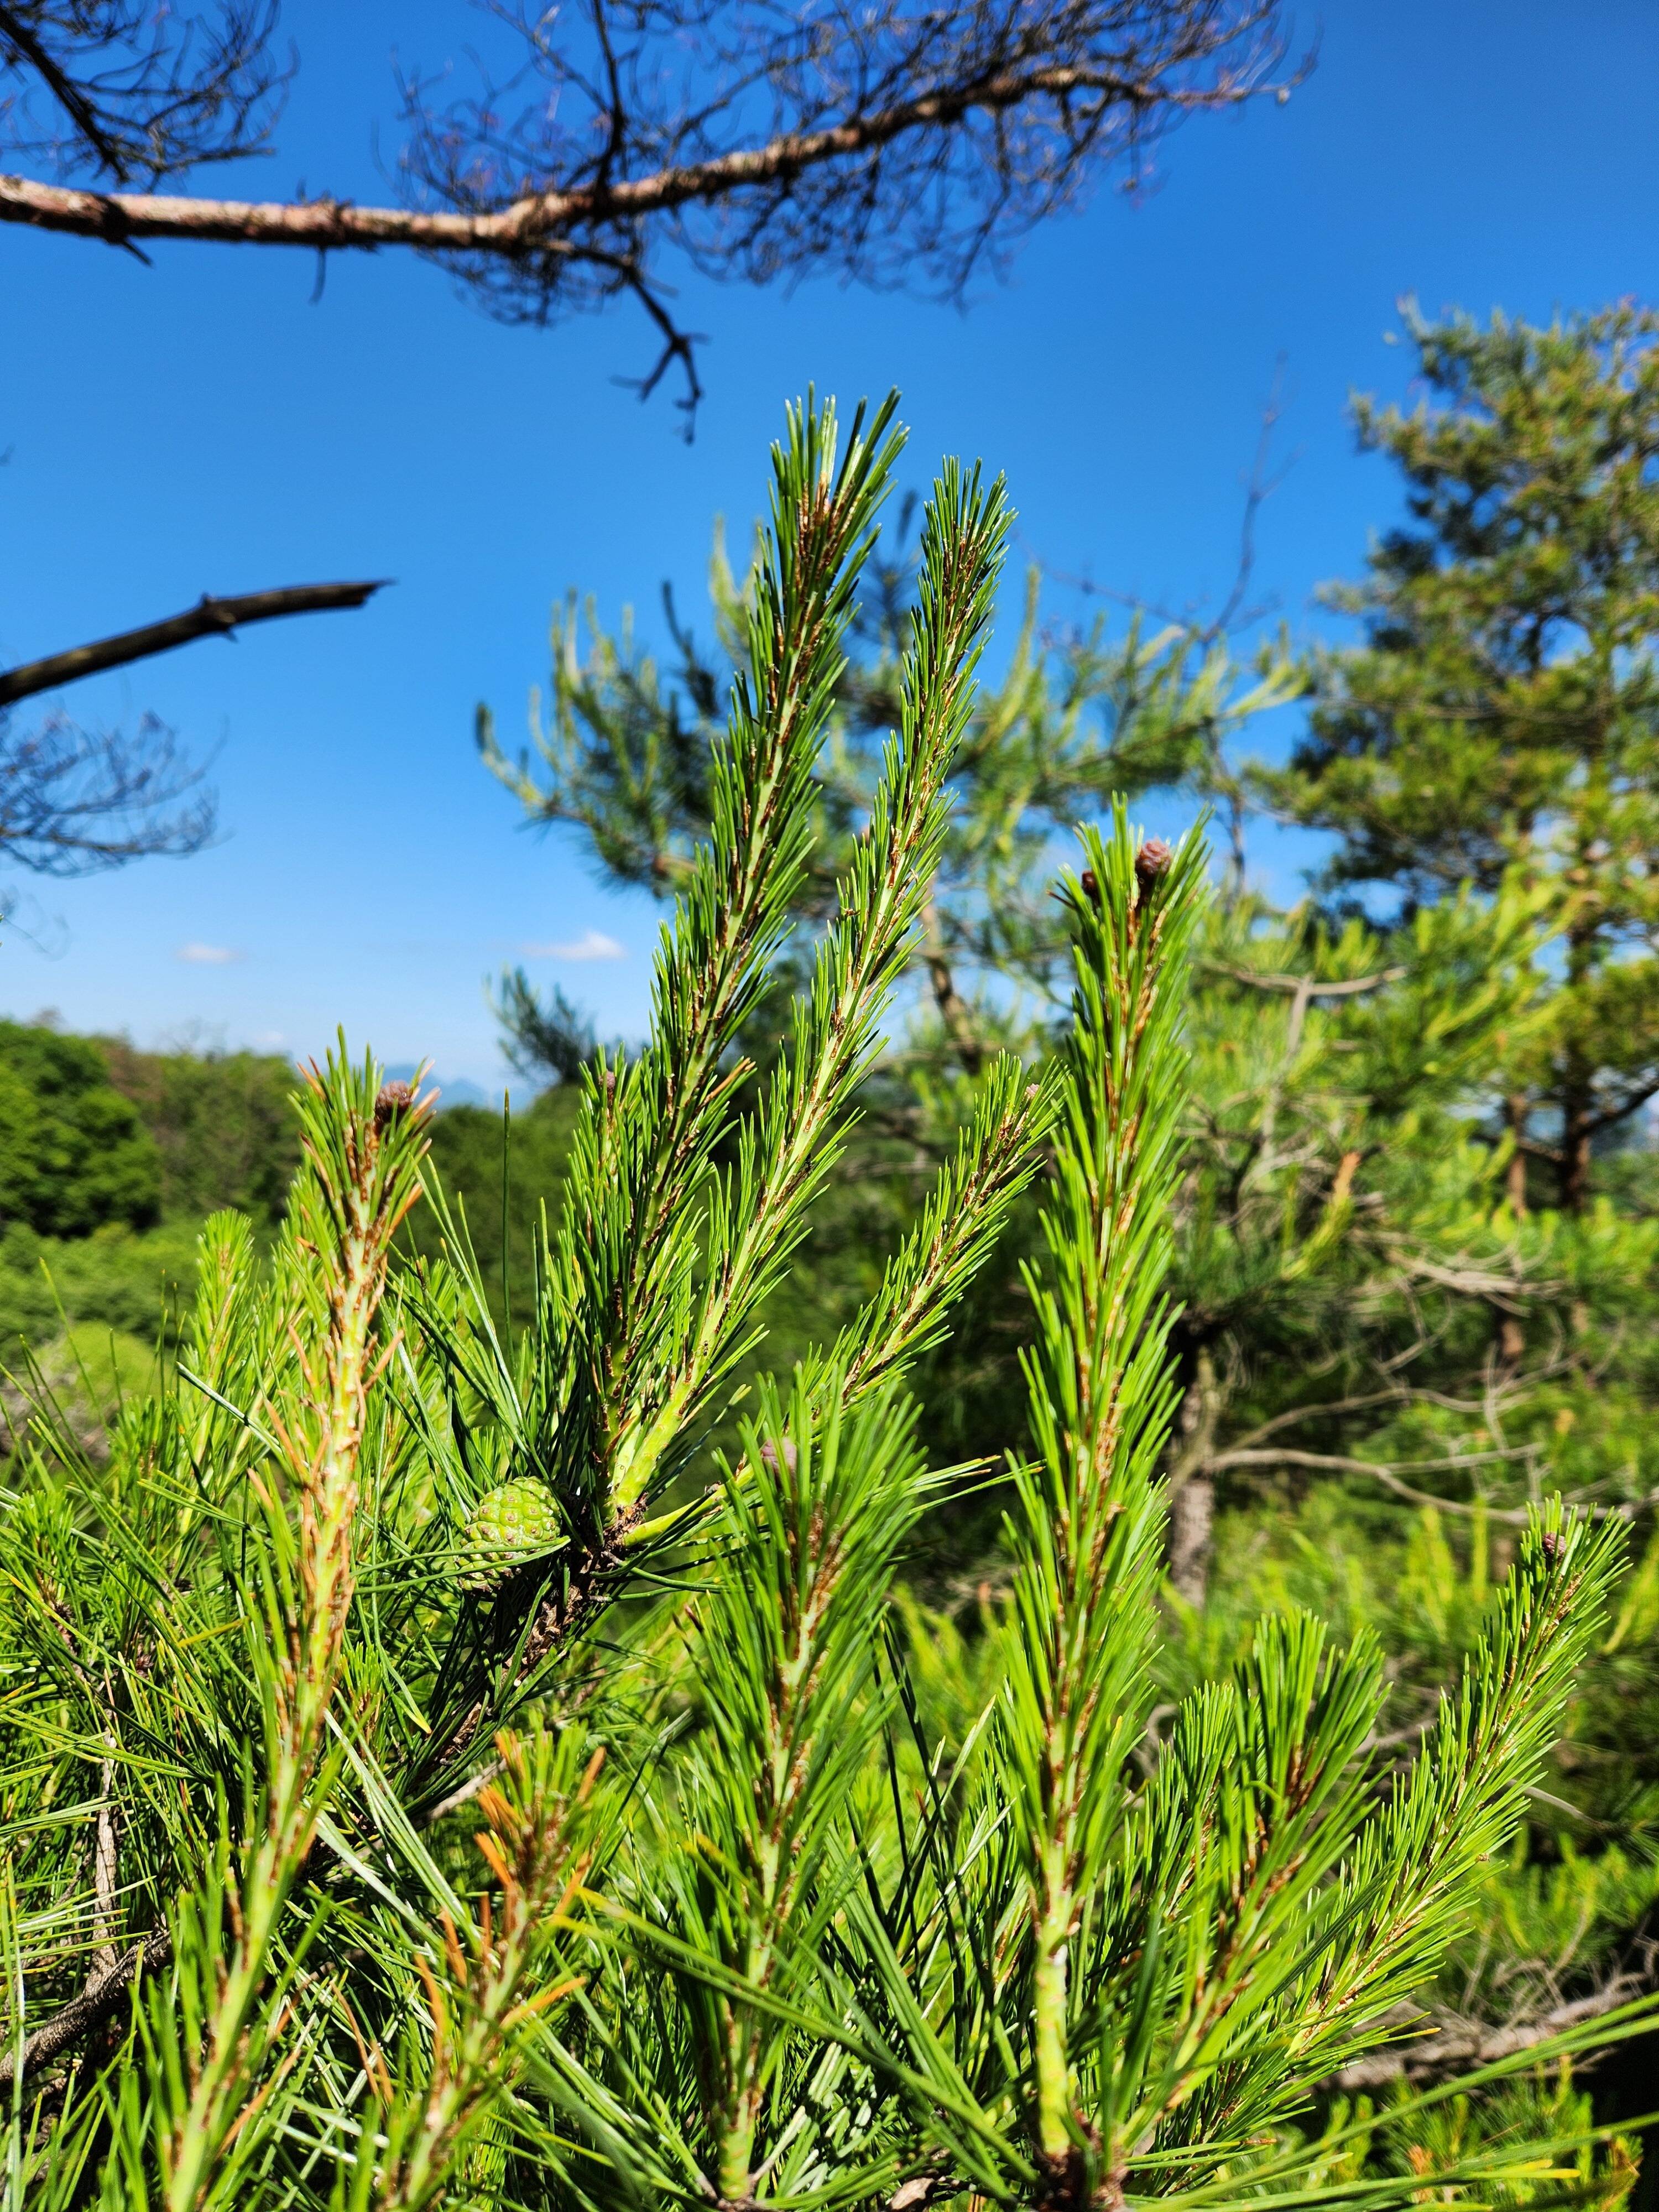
[637, 1371, 927, 2205]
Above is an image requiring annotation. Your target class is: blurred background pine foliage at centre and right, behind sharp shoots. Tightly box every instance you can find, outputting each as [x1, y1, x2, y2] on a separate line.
[465, 332, 1659, 2194]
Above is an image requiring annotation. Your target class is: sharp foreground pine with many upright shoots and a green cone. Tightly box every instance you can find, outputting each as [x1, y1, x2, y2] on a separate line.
[0, 403, 1646, 2212]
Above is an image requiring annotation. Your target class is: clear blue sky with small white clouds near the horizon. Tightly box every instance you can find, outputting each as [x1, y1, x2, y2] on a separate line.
[0, 0, 1659, 1082]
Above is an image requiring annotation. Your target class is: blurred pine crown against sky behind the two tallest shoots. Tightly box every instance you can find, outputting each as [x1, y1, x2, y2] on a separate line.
[476, 507, 1303, 1077]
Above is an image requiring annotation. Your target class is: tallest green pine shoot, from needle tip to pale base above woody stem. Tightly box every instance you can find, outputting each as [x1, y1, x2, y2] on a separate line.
[564, 398, 898, 1526]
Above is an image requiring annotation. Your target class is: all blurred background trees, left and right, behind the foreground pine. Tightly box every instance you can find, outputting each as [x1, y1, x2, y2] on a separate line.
[0, 305, 1659, 2201]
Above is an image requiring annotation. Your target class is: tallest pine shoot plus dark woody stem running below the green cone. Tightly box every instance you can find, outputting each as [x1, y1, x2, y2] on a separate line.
[416, 396, 902, 1794]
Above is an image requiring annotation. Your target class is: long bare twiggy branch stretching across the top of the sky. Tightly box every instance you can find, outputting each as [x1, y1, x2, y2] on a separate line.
[0, 0, 1301, 407]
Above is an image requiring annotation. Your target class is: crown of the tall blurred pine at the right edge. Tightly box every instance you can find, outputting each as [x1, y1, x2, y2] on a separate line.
[1267, 305, 1659, 1212]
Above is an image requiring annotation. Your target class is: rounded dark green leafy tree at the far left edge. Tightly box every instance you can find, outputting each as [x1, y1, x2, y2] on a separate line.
[0, 1022, 161, 1237]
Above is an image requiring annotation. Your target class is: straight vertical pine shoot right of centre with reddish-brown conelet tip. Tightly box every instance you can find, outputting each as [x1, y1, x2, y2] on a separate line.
[998, 805, 1203, 2197]
